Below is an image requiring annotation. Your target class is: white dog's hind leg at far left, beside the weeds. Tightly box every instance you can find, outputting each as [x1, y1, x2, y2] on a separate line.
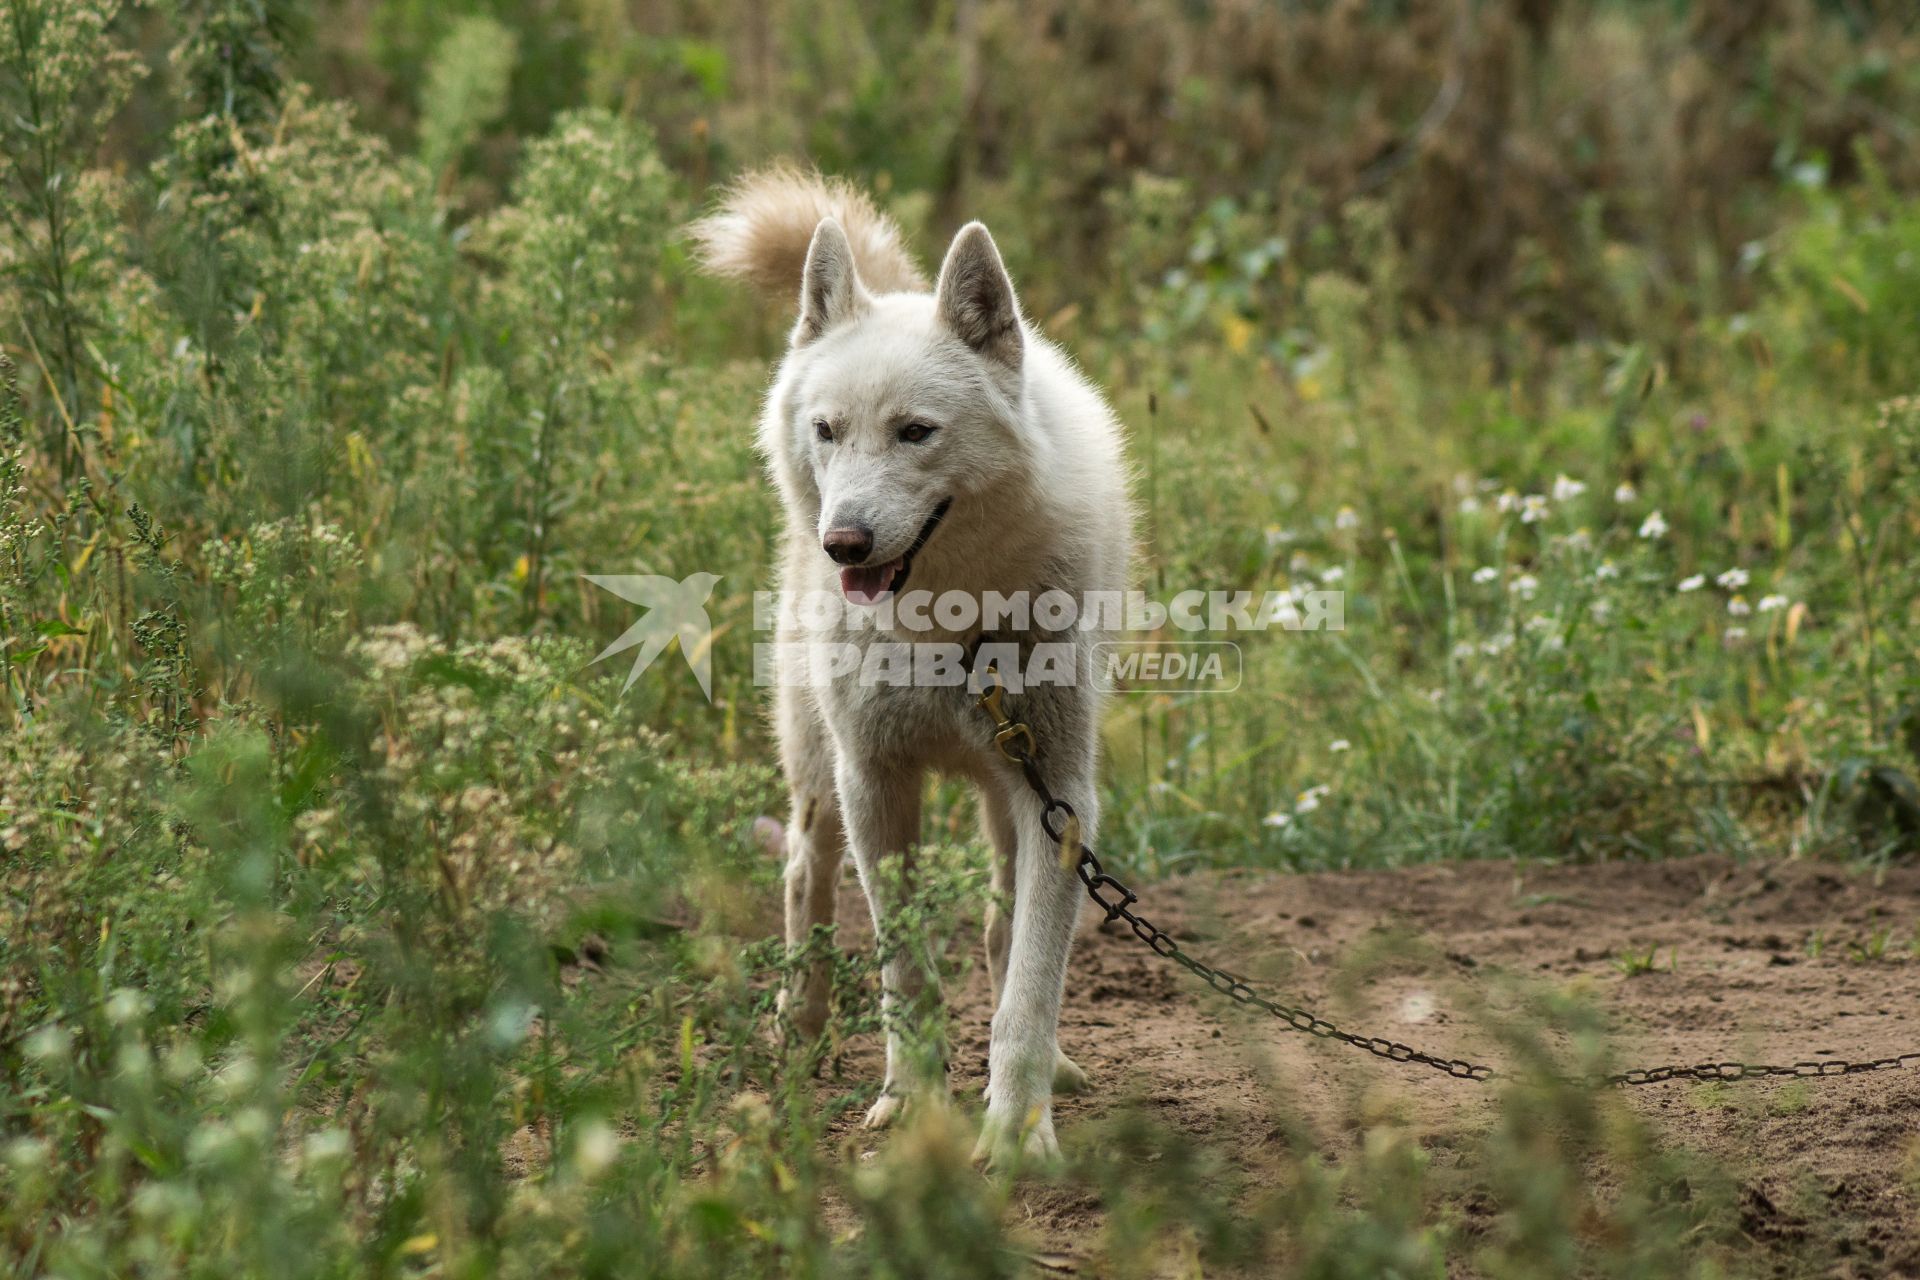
[774, 687, 847, 1042]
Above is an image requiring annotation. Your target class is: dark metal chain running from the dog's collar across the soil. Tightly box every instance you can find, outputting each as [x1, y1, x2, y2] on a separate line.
[977, 664, 1920, 1088]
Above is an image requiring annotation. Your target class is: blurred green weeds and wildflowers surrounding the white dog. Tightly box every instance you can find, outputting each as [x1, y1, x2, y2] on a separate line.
[0, 0, 1920, 1276]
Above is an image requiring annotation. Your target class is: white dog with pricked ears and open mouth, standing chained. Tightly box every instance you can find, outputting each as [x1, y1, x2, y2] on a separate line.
[691, 171, 1133, 1161]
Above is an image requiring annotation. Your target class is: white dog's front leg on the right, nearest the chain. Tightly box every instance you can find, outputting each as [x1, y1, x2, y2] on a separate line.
[975, 768, 1098, 1165]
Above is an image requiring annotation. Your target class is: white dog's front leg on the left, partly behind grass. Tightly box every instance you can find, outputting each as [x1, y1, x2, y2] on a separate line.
[837, 756, 947, 1128]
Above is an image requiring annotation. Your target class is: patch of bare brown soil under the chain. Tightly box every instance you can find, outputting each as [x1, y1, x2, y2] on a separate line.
[817, 858, 1920, 1276]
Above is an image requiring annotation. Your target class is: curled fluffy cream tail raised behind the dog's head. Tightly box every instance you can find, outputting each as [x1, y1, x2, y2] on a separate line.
[687, 167, 927, 297]
